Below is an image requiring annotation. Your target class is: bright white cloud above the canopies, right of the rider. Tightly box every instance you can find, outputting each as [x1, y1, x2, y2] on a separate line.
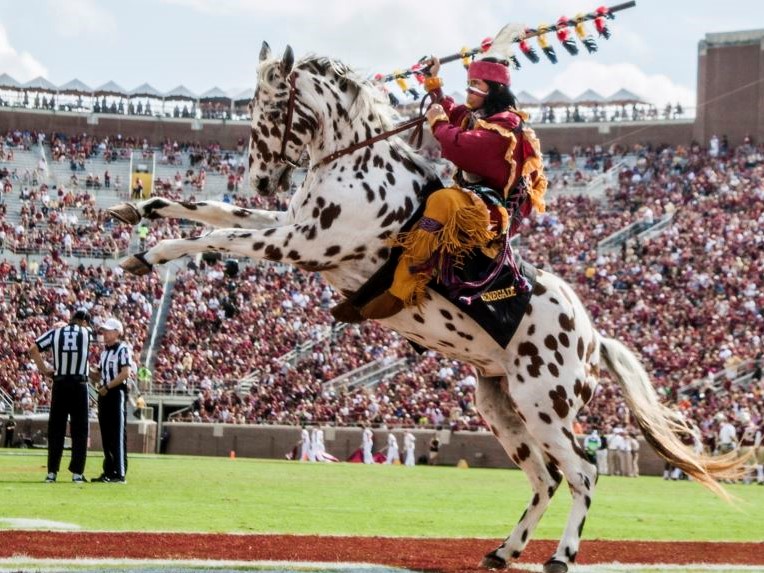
[534, 60, 696, 107]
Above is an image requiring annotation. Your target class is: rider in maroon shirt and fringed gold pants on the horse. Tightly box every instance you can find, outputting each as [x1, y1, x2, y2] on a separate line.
[360, 57, 547, 319]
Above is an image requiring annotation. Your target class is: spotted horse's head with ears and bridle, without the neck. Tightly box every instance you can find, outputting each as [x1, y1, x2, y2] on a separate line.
[249, 42, 316, 195]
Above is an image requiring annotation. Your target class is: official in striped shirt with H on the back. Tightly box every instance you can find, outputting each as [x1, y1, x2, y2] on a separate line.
[29, 309, 93, 483]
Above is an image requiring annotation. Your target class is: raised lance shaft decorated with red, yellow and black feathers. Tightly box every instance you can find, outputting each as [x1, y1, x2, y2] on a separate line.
[375, 0, 637, 83]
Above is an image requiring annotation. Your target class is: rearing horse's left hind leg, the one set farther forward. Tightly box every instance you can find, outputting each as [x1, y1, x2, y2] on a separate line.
[477, 377, 562, 569]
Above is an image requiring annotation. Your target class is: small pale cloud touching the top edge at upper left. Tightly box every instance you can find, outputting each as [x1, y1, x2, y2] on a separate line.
[48, 0, 117, 38]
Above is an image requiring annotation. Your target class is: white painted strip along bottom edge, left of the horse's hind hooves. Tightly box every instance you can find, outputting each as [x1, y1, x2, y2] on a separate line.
[0, 557, 413, 573]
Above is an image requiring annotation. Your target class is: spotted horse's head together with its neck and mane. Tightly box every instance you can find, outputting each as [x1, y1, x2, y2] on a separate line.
[249, 42, 391, 195]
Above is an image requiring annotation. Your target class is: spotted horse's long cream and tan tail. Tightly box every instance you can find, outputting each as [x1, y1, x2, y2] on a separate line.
[599, 336, 746, 501]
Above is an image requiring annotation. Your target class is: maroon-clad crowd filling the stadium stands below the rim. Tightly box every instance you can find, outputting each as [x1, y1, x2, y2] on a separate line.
[0, 126, 764, 460]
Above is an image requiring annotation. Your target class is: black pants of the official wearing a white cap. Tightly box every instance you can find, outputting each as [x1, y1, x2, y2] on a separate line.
[98, 387, 127, 479]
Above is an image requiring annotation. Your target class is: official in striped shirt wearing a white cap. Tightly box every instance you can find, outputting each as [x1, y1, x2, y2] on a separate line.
[90, 318, 133, 483]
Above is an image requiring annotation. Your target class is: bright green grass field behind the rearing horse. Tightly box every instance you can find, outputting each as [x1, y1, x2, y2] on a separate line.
[0, 450, 764, 541]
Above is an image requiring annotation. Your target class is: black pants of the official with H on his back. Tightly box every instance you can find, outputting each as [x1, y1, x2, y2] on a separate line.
[48, 376, 89, 474]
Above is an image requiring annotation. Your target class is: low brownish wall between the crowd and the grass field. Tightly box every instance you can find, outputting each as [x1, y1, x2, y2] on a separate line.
[0, 416, 663, 475]
